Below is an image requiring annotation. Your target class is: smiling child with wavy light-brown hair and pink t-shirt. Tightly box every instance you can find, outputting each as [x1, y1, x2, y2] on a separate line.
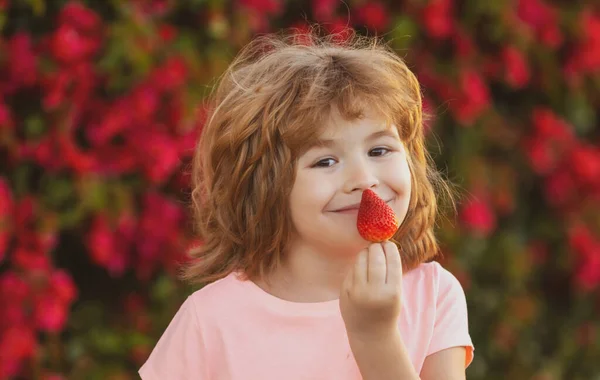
[139, 29, 473, 380]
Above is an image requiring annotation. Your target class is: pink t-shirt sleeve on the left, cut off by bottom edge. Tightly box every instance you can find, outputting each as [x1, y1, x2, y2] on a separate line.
[138, 297, 208, 380]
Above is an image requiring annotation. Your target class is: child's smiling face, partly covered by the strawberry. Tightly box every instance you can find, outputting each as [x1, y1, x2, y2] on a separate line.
[290, 110, 411, 254]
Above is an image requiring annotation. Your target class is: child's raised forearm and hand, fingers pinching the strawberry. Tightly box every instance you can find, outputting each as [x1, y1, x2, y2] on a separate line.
[340, 242, 419, 380]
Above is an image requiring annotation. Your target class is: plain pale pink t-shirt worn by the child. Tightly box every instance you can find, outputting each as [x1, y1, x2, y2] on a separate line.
[139, 262, 474, 380]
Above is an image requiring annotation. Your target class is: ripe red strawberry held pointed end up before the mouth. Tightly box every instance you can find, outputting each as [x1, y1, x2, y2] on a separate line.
[356, 189, 400, 243]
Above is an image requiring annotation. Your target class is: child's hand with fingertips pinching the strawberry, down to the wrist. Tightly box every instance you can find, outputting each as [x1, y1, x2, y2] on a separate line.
[340, 241, 402, 337]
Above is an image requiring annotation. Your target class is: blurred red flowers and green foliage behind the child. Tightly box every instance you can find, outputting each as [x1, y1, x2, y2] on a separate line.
[0, 0, 600, 380]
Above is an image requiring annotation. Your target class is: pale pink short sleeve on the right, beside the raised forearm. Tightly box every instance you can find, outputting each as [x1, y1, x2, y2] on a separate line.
[427, 266, 475, 368]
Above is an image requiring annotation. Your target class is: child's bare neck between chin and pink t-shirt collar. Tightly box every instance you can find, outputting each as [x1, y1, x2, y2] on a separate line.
[255, 245, 355, 302]
